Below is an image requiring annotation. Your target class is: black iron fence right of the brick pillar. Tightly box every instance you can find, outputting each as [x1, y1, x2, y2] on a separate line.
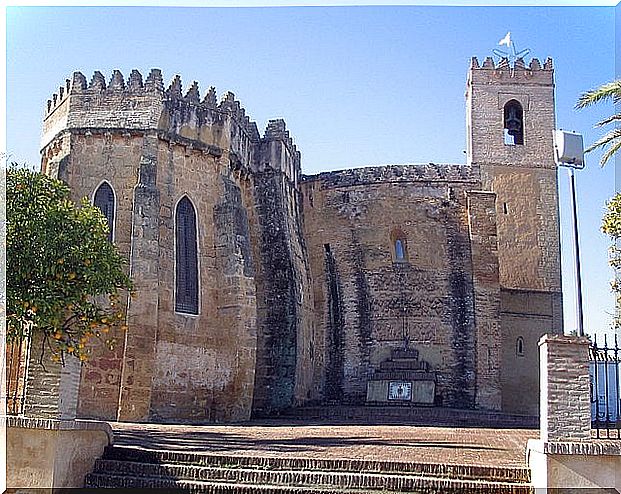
[589, 335, 621, 439]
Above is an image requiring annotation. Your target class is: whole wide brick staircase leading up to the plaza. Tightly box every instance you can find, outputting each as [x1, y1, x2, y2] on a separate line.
[86, 446, 533, 494]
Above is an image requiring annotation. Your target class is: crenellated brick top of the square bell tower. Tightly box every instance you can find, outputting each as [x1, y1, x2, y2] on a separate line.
[468, 57, 554, 86]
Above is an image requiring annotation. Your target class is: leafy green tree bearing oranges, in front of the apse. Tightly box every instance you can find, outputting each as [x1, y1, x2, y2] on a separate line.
[6, 165, 131, 362]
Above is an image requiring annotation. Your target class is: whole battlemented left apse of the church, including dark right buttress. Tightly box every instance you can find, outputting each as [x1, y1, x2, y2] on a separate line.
[37, 69, 318, 421]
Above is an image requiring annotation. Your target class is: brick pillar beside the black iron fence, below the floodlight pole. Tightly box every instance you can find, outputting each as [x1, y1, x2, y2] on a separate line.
[539, 335, 591, 442]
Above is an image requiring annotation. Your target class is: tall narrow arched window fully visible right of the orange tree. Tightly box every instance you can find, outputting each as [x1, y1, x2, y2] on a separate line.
[175, 197, 198, 314]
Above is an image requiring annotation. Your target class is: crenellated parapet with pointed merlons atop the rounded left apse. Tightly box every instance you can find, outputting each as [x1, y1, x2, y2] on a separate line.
[41, 69, 260, 171]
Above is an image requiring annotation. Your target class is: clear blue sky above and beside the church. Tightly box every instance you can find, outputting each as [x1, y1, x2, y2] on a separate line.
[6, 2, 618, 340]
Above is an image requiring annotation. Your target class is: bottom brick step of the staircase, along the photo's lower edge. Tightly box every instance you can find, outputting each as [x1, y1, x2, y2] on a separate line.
[85, 473, 532, 494]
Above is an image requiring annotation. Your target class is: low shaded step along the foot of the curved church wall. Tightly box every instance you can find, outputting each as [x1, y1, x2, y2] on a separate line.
[281, 403, 539, 429]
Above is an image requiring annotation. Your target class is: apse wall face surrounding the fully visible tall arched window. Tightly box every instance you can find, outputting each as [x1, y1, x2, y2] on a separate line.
[145, 142, 256, 421]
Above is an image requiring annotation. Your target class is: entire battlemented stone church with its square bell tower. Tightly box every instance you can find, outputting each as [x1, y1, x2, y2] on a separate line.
[36, 58, 562, 422]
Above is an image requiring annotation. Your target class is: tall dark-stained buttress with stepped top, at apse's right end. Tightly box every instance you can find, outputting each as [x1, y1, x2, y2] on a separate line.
[253, 120, 318, 416]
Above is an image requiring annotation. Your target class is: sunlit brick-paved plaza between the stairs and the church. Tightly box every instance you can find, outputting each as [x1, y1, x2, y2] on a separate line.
[111, 421, 539, 467]
